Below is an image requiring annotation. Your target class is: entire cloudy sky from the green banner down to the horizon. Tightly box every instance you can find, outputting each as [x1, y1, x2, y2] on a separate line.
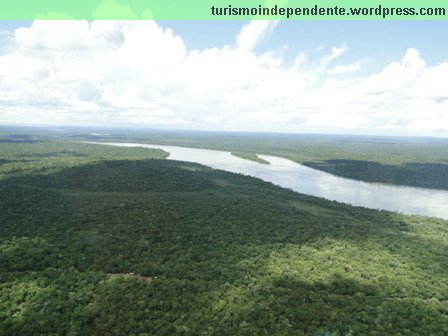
[0, 21, 448, 137]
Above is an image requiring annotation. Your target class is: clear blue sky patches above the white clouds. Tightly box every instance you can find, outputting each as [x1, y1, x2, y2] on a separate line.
[159, 21, 448, 70]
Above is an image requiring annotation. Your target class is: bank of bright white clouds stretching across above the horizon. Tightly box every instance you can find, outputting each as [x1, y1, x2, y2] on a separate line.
[0, 21, 448, 135]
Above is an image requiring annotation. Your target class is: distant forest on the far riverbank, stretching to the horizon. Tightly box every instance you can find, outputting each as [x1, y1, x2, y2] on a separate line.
[0, 127, 448, 190]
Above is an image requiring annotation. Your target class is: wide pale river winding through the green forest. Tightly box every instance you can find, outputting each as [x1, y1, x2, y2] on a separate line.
[89, 142, 448, 219]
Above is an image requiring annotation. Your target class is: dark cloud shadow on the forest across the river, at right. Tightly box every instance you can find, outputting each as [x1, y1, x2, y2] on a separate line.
[304, 160, 448, 189]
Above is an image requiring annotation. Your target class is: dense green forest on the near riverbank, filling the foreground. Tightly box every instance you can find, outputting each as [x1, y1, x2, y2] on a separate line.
[0, 135, 448, 336]
